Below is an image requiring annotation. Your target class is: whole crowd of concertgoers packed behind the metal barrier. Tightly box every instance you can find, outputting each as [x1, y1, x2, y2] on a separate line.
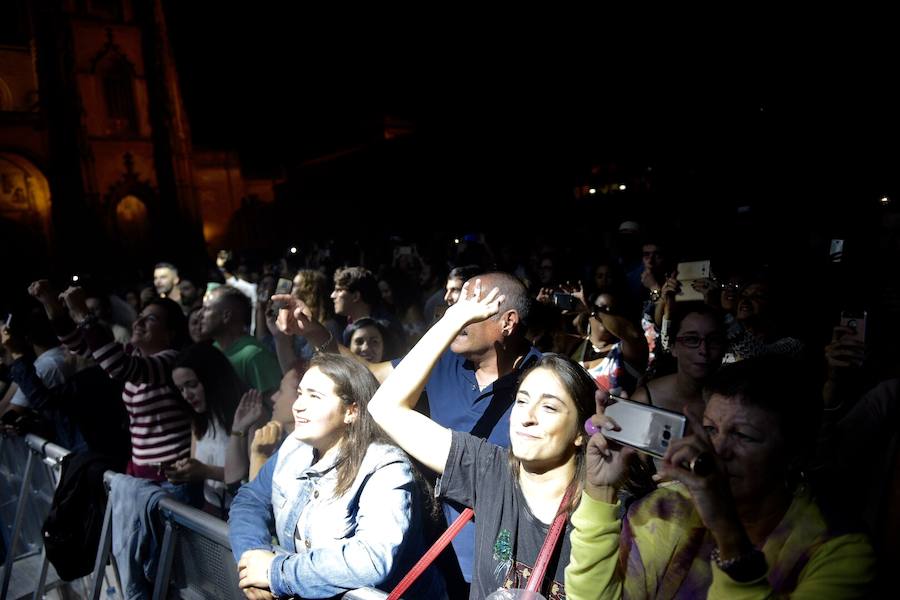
[0, 221, 900, 600]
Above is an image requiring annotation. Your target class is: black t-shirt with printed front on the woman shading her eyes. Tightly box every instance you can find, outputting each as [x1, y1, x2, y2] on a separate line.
[437, 431, 571, 600]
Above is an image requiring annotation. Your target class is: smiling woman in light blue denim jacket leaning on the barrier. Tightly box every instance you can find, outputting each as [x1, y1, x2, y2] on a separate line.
[229, 354, 446, 598]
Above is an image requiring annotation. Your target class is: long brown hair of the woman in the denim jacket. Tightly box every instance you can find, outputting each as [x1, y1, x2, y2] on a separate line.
[309, 353, 390, 496]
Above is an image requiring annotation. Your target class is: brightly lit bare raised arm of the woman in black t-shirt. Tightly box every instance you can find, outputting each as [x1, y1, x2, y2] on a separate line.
[369, 279, 504, 473]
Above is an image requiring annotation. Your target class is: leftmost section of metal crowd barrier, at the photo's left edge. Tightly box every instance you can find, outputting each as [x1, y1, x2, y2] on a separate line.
[0, 434, 69, 600]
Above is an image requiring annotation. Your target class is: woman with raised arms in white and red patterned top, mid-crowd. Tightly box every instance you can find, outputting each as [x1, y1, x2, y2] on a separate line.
[572, 290, 648, 393]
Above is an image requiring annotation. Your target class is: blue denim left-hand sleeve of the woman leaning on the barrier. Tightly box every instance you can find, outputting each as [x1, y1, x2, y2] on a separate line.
[228, 452, 278, 562]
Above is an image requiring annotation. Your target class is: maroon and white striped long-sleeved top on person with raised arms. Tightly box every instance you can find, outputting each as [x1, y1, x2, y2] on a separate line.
[60, 324, 191, 466]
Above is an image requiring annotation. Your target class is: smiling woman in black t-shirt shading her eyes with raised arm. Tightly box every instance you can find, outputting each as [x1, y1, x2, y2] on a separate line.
[369, 279, 597, 599]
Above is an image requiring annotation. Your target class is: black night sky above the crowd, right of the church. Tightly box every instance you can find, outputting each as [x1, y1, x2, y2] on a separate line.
[166, 2, 900, 229]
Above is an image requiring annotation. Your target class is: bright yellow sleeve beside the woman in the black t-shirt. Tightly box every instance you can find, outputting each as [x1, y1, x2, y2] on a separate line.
[566, 493, 623, 600]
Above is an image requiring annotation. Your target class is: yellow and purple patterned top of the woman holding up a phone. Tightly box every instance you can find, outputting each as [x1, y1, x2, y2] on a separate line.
[566, 483, 875, 600]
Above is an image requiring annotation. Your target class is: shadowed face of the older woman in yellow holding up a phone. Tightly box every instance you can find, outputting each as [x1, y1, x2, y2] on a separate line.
[703, 394, 790, 503]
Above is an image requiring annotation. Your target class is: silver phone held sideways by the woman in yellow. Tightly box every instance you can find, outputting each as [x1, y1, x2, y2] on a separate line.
[603, 396, 687, 458]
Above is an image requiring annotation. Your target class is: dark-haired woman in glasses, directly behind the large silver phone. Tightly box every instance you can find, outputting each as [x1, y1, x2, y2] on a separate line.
[633, 302, 728, 413]
